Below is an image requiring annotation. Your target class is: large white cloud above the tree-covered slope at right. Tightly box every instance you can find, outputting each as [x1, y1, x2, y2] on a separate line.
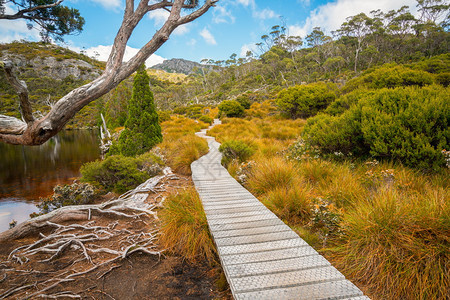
[289, 0, 416, 37]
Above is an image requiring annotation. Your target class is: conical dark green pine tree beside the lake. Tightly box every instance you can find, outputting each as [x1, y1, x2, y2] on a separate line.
[117, 65, 162, 156]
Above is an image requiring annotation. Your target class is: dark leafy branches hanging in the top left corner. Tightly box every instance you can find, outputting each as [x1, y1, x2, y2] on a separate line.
[0, 0, 84, 41]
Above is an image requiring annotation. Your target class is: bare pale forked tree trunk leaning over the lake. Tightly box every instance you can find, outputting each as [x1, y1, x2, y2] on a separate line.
[0, 0, 219, 145]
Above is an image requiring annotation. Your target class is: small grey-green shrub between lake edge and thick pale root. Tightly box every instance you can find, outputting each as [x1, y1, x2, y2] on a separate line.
[37, 183, 98, 214]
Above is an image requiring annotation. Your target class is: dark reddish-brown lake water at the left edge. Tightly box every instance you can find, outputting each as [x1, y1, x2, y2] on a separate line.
[0, 130, 100, 232]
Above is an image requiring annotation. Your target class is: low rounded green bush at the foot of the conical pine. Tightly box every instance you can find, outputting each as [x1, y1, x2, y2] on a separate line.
[80, 154, 160, 193]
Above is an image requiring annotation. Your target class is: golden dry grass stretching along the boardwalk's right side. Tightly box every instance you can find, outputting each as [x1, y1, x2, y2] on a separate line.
[211, 117, 450, 299]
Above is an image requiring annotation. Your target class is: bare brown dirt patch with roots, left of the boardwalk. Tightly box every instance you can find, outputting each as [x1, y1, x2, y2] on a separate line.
[0, 176, 231, 299]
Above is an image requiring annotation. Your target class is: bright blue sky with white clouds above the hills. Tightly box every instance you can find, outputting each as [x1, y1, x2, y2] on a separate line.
[0, 0, 416, 65]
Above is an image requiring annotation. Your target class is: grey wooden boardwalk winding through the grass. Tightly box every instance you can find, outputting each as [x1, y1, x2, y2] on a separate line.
[191, 120, 369, 300]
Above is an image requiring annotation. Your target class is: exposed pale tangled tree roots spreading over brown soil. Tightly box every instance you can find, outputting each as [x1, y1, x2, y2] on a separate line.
[0, 172, 171, 299]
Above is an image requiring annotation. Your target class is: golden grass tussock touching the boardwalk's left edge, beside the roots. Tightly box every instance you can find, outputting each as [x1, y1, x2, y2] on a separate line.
[158, 188, 217, 263]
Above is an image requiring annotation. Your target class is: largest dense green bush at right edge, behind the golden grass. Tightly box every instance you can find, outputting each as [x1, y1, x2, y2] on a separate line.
[303, 85, 450, 171]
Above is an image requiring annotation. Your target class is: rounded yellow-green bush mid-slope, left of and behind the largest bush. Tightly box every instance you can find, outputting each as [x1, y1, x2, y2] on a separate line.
[277, 82, 336, 119]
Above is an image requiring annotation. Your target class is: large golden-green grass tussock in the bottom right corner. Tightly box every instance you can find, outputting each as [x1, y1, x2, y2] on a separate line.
[332, 189, 450, 299]
